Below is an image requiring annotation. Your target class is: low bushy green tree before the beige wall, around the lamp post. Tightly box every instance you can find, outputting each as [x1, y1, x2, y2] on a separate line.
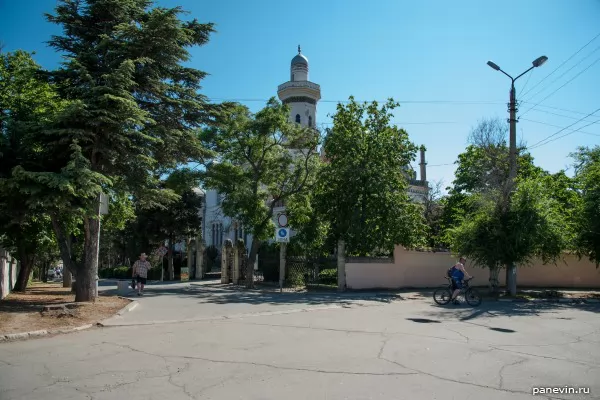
[447, 178, 570, 291]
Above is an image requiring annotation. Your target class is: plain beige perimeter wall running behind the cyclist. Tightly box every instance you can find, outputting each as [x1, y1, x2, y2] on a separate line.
[346, 247, 600, 289]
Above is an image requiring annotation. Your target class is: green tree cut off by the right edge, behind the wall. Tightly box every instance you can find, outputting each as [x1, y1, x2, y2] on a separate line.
[572, 146, 600, 268]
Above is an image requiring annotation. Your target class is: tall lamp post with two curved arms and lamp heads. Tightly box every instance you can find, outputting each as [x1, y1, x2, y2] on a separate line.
[487, 56, 548, 296]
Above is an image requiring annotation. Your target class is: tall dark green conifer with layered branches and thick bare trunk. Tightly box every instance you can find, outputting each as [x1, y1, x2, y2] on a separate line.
[15, 0, 216, 301]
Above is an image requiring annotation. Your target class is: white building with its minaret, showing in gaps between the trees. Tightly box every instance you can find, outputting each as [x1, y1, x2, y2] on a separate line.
[202, 46, 427, 250]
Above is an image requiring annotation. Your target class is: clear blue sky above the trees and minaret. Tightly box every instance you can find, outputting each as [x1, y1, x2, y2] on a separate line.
[0, 0, 600, 189]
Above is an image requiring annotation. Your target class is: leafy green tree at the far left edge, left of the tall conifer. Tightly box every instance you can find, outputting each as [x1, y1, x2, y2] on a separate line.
[0, 51, 64, 291]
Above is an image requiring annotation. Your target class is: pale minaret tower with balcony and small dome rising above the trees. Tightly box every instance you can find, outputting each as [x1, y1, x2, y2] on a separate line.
[277, 45, 321, 128]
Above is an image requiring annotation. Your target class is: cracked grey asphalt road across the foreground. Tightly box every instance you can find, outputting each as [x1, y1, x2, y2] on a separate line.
[0, 285, 600, 400]
